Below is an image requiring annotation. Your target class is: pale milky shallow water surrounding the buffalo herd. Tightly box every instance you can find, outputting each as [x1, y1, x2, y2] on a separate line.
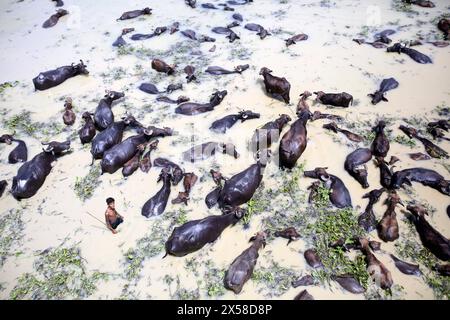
[0, 0, 450, 299]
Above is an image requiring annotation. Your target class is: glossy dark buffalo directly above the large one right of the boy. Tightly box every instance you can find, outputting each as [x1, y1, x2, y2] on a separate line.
[218, 161, 263, 209]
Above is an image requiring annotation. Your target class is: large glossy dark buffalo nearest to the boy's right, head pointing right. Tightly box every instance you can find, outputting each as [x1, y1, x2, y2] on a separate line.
[165, 208, 245, 257]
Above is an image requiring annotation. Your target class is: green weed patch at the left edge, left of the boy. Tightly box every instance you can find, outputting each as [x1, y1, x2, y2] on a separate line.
[0, 209, 25, 267]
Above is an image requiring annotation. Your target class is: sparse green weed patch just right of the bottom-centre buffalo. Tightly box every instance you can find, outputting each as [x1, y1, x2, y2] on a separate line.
[251, 260, 297, 297]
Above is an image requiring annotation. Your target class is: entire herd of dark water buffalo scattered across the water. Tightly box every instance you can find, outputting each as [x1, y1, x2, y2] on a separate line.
[0, 0, 450, 299]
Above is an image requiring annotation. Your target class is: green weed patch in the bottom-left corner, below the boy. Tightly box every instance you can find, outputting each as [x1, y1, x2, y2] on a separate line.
[10, 247, 109, 300]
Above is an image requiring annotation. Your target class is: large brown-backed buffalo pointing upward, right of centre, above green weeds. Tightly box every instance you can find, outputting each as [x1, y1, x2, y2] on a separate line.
[279, 110, 311, 169]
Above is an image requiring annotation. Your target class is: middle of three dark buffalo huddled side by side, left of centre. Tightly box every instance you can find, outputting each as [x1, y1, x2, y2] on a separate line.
[91, 115, 141, 163]
